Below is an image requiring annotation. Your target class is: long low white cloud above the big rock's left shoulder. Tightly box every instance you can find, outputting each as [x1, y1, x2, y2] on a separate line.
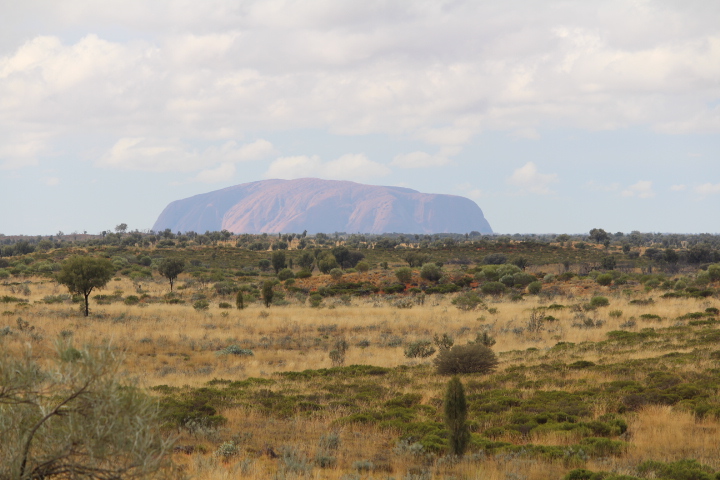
[96, 137, 275, 172]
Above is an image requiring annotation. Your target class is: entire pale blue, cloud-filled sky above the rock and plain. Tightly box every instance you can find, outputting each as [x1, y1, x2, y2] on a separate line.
[0, 0, 720, 235]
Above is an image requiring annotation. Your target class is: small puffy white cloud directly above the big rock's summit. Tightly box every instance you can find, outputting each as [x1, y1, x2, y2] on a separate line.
[264, 154, 391, 180]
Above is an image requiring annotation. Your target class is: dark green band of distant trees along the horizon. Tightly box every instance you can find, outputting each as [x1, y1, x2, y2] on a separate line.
[0, 228, 720, 271]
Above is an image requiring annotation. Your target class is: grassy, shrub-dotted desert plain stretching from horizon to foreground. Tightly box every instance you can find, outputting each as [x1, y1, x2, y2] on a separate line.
[0, 230, 720, 480]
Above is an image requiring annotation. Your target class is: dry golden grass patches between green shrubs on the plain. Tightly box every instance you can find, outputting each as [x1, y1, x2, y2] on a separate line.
[5, 272, 720, 480]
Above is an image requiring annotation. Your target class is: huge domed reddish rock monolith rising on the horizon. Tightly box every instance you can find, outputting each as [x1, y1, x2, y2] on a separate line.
[153, 178, 492, 234]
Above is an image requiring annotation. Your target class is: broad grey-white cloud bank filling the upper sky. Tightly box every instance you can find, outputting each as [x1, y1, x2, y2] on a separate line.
[0, 0, 720, 163]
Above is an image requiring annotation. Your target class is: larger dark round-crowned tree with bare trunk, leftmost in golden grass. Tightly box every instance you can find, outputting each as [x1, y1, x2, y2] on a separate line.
[55, 255, 115, 317]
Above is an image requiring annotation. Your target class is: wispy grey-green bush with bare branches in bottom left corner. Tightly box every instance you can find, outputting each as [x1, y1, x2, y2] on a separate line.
[0, 344, 172, 479]
